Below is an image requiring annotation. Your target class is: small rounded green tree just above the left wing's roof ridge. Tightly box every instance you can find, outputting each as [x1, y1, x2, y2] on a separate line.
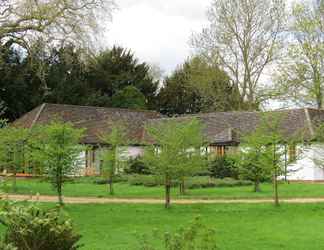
[111, 86, 146, 109]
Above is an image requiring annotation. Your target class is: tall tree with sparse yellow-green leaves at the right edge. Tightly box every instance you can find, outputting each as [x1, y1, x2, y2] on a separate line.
[275, 1, 324, 108]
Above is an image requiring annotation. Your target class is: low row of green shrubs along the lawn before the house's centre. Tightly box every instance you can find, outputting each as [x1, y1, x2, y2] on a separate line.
[128, 175, 252, 189]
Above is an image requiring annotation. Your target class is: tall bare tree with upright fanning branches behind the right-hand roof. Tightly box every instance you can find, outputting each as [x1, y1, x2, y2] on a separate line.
[191, 0, 285, 109]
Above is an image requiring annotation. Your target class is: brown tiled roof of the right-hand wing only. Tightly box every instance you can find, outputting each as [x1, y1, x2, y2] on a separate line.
[149, 109, 324, 144]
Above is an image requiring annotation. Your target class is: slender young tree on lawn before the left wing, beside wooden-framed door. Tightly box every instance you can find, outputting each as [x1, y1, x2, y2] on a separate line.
[102, 124, 128, 195]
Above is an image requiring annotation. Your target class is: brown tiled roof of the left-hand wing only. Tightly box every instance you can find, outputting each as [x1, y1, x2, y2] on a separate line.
[13, 103, 161, 144]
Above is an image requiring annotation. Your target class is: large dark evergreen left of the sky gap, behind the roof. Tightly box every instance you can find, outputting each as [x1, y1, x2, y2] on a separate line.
[88, 46, 158, 108]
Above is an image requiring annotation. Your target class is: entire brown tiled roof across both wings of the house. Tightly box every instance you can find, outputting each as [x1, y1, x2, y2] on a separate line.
[13, 104, 324, 144]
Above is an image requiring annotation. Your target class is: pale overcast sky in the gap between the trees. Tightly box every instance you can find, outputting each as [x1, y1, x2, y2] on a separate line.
[107, 0, 211, 73]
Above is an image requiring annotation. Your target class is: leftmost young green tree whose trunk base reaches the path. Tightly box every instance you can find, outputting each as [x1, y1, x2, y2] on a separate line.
[31, 121, 84, 205]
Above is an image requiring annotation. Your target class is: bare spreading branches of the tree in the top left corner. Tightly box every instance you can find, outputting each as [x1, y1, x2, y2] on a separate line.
[0, 0, 114, 49]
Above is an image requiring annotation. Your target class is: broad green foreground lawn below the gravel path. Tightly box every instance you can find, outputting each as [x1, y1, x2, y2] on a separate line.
[1, 204, 324, 250]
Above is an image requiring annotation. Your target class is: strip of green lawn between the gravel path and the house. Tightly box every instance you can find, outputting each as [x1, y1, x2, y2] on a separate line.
[5, 179, 324, 199]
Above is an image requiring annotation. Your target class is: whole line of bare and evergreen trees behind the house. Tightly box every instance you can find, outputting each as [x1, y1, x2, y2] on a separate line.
[0, 0, 324, 120]
